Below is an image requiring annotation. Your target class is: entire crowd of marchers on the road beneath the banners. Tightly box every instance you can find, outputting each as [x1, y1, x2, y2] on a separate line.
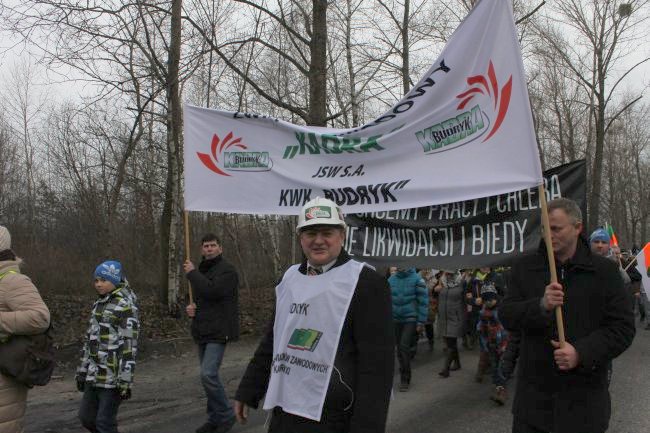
[0, 198, 636, 433]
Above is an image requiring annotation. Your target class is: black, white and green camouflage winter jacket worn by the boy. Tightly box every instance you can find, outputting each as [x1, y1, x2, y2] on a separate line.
[76, 282, 140, 388]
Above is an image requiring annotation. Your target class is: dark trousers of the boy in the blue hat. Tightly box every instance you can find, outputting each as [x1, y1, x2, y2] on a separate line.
[79, 383, 122, 433]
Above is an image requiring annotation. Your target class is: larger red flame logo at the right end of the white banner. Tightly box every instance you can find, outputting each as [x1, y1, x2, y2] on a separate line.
[456, 60, 512, 142]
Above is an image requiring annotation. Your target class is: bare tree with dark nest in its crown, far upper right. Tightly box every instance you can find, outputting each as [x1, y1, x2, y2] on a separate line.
[539, 0, 650, 230]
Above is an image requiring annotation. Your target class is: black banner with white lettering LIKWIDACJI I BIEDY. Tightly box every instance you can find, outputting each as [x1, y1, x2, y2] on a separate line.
[345, 160, 586, 269]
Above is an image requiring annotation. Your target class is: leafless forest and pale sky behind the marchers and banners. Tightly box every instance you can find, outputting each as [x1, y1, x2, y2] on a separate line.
[0, 0, 650, 345]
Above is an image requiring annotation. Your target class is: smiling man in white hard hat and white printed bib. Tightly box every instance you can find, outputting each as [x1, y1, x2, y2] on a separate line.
[235, 198, 395, 433]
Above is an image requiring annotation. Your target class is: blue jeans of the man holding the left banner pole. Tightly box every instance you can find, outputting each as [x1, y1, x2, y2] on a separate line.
[199, 343, 235, 425]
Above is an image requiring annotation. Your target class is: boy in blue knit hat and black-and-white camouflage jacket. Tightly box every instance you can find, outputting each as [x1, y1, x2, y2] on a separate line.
[75, 260, 140, 433]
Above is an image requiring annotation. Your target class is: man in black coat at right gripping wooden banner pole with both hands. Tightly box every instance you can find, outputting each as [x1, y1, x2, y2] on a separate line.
[500, 199, 635, 433]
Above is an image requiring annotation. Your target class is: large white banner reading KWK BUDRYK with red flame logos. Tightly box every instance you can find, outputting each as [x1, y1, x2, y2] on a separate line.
[184, 0, 542, 214]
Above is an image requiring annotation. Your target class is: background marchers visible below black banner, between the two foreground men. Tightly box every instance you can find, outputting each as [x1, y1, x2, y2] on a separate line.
[388, 267, 519, 405]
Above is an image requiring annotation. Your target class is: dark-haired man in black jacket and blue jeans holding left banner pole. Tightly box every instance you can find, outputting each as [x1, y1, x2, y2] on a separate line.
[183, 233, 239, 433]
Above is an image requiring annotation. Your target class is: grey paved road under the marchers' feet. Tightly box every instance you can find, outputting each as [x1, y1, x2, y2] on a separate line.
[26, 318, 650, 433]
